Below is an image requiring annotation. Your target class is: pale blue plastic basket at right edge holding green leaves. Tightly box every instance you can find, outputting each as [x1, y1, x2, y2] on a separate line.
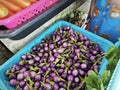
[107, 41, 120, 90]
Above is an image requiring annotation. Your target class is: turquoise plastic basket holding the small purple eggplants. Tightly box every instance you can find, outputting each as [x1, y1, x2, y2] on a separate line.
[0, 21, 113, 90]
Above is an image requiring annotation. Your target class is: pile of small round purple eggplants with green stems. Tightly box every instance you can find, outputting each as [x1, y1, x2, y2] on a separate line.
[6, 26, 104, 90]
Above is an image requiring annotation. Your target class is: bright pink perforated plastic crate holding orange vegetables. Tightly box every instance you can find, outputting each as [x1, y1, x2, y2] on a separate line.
[0, 0, 59, 29]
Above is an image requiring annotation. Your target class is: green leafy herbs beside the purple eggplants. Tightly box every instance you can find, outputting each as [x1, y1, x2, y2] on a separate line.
[85, 46, 120, 90]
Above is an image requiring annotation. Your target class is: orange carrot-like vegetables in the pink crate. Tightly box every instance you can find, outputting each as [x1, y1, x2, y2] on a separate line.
[0, 0, 37, 19]
